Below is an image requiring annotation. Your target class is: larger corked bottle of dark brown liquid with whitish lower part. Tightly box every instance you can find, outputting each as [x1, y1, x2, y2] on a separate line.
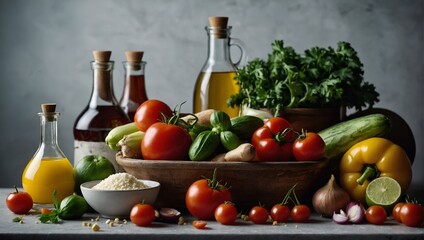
[73, 51, 130, 172]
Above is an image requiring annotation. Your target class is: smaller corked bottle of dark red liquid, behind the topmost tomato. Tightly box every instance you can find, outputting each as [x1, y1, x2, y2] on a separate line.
[119, 51, 147, 121]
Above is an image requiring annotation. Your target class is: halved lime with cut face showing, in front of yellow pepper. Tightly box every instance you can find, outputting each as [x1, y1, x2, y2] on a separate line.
[365, 177, 402, 212]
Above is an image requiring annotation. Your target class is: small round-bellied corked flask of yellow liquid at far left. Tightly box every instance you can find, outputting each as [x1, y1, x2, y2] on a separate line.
[22, 103, 75, 204]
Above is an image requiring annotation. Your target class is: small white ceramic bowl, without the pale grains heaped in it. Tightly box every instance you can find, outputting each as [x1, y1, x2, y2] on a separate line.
[80, 179, 160, 218]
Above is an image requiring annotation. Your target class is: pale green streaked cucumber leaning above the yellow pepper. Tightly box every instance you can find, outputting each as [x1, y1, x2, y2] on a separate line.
[318, 113, 391, 159]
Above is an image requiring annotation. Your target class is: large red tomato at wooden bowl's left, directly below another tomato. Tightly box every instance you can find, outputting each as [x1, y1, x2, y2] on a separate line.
[141, 122, 192, 160]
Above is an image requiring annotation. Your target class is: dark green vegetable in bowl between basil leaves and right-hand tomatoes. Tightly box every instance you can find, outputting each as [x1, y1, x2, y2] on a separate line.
[230, 115, 264, 141]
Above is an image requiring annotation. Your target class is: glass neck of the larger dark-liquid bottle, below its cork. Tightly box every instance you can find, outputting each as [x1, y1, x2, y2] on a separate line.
[89, 61, 118, 108]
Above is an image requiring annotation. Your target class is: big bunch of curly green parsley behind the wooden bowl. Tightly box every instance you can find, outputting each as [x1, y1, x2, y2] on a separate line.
[227, 40, 379, 115]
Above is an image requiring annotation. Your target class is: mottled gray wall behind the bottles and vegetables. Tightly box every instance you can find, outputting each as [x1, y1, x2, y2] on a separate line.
[0, 0, 424, 187]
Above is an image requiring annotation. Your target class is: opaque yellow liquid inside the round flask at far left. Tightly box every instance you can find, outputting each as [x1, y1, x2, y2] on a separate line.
[22, 158, 75, 204]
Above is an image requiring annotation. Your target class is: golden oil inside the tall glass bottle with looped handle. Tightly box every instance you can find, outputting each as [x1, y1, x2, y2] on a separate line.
[193, 72, 240, 118]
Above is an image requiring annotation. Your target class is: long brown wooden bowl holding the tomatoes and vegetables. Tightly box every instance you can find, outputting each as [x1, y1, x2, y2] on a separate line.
[116, 153, 328, 209]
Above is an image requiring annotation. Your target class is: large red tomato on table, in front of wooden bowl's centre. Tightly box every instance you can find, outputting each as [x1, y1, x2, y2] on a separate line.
[185, 171, 232, 220]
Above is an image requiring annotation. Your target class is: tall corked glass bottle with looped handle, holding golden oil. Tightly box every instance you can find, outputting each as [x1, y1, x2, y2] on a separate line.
[193, 17, 247, 117]
